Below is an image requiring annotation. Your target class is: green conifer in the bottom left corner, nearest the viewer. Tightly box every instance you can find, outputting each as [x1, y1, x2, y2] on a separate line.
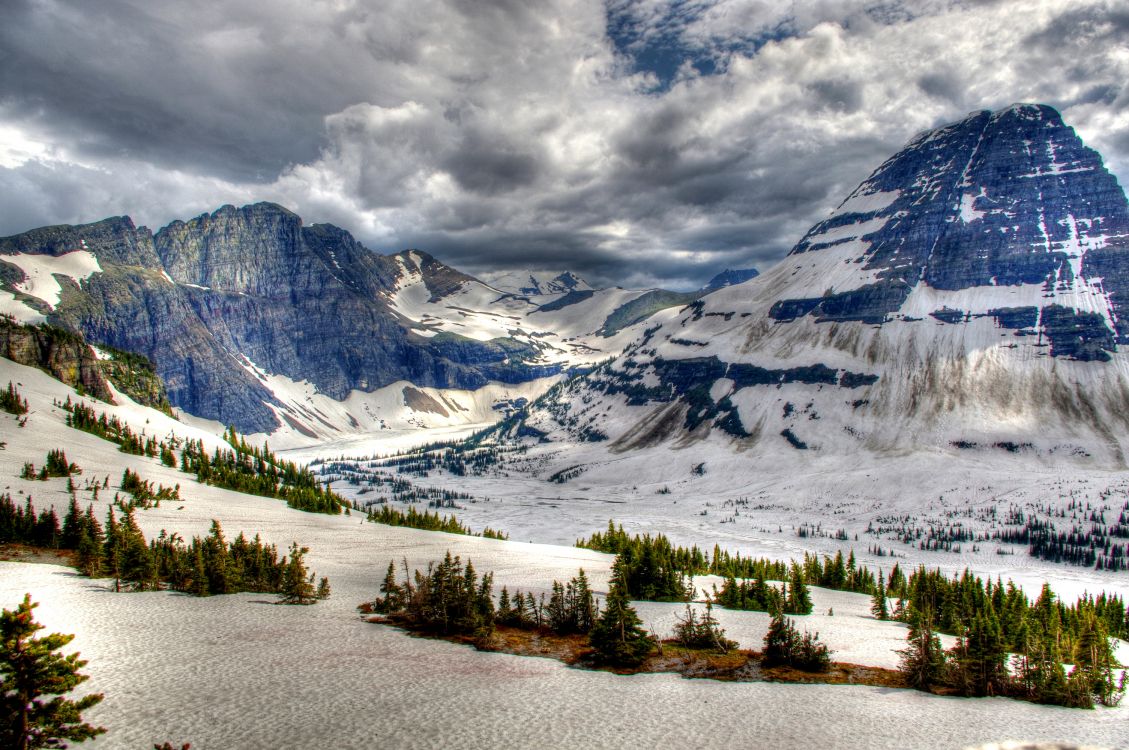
[0, 594, 106, 750]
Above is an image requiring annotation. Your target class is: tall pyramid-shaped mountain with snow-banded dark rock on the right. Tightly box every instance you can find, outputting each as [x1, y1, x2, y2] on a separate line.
[526, 105, 1129, 465]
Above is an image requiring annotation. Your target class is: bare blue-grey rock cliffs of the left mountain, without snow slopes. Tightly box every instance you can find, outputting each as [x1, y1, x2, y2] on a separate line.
[0, 203, 578, 433]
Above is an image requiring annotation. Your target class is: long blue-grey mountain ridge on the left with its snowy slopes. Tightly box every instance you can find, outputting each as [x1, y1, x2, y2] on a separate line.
[0, 203, 677, 438]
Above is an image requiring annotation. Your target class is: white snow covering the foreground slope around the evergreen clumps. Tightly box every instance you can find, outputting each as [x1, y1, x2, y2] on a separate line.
[0, 360, 1129, 750]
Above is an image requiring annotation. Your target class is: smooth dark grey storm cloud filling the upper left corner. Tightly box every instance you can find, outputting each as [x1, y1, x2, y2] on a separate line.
[0, 0, 350, 180]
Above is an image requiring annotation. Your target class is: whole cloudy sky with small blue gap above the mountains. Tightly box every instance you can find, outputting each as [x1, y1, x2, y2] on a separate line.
[0, 0, 1129, 288]
